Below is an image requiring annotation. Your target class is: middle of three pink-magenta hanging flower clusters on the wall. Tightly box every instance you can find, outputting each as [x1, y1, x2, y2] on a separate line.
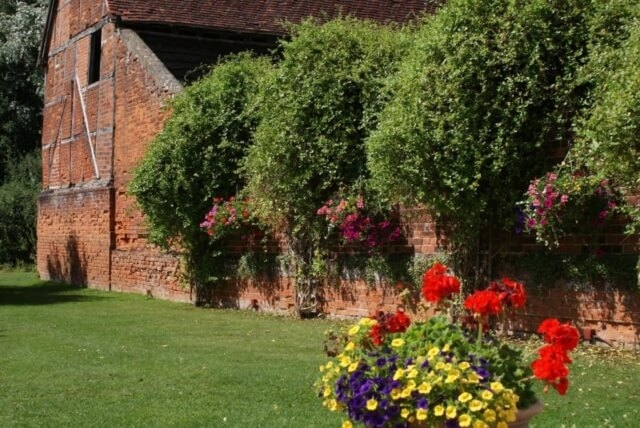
[317, 194, 402, 248]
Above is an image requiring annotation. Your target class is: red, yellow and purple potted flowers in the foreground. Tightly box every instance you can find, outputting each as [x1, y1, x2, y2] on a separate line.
[316, 263, 579, 428]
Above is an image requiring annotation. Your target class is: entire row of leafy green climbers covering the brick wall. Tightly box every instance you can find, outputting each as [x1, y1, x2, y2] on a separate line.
[131, 0, 640, 300]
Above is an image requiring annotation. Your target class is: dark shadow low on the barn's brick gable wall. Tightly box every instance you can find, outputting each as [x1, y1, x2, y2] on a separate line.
[47, 233, 87, 287]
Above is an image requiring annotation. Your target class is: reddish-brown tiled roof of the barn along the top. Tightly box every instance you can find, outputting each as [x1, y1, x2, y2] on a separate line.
[107, 0, 434, 34]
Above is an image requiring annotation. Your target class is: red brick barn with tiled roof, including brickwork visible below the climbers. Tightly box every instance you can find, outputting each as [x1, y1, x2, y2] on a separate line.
[37, 0, 640, 344]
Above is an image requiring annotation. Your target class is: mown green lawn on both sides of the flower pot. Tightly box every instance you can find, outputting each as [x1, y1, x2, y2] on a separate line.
[0, 272, 640, 428]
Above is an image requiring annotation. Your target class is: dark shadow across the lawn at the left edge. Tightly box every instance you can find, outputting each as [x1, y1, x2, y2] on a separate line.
[0, 281, 101, 306]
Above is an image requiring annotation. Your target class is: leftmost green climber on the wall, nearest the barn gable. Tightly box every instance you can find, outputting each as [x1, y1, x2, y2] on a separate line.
[129, 54, 272, 284]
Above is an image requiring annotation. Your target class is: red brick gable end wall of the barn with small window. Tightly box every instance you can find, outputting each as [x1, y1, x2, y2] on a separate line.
[38, 0, 185, 301]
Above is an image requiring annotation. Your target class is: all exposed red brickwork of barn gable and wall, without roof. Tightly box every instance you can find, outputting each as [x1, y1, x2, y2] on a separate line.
[37, 0, 640, 344]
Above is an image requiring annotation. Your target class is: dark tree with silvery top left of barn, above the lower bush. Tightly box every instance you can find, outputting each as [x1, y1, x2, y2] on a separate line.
[0, 0, 47, 182]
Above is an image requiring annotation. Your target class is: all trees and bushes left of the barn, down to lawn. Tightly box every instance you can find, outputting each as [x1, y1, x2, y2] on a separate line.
[0, 0, 47, 263]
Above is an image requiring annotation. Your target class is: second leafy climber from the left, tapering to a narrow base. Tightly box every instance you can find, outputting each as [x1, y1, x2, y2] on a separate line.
[245, 19, 409, 284]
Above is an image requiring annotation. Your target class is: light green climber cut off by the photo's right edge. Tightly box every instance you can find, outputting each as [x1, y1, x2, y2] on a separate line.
[571, 1, 640, 231]
